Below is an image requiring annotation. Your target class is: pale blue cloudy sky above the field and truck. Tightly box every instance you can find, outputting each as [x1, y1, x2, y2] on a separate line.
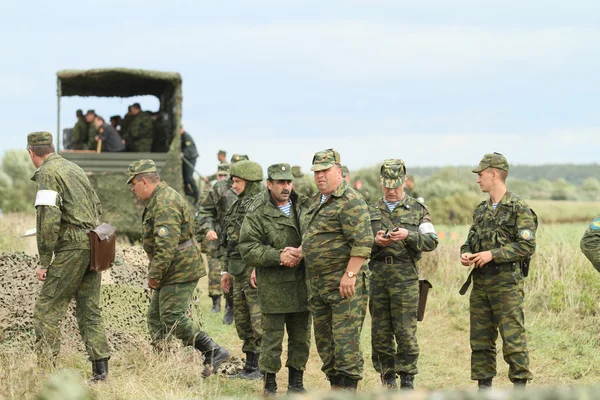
[0, 0, 600, 174]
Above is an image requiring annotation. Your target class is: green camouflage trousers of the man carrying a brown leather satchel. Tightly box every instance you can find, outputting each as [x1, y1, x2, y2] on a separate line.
[33, 250, 110, 365]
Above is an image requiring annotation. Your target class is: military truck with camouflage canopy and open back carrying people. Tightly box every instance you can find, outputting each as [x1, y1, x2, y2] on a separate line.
[56, 68, 183, 240]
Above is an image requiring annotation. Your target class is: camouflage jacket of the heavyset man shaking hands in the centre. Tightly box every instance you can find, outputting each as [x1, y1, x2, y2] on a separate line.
[302, 181, 373, 275]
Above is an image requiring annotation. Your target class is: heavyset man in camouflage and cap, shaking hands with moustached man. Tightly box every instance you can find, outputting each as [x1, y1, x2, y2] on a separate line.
[302, 149, 373, 390]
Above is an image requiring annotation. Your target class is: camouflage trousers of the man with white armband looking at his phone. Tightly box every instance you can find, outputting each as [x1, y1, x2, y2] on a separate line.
[369, 261, 419, 375]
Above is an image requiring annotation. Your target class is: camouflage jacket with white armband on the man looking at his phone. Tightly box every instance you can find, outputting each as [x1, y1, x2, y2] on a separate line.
[369, 195, 439, 263]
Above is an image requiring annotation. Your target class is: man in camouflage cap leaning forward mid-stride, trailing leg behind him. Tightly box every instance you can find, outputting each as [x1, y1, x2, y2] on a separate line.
[127, 160, 229, 378]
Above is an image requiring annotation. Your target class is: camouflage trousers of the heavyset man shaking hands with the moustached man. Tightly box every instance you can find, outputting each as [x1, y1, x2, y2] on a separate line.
[309, 271, 369, 379]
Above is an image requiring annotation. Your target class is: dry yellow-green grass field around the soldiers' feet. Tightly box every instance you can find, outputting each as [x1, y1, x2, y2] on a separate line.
[0, 211, 600, 399]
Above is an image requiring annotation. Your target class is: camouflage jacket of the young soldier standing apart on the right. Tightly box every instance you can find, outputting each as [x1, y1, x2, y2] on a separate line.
[460, 192, 537, 263]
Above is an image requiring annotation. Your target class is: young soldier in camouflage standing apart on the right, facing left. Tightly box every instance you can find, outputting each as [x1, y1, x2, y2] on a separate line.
[460, 153, 537, 389]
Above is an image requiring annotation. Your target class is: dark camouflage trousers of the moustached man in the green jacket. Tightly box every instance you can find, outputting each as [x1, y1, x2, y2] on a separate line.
[258, 311, 310, 374]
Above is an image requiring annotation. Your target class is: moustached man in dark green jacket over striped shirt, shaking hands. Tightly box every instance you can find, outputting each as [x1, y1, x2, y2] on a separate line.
[240, 164, 310, 396]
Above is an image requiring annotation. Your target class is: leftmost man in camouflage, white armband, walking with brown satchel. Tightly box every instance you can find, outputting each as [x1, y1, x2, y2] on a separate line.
[27, 132, 110, 381]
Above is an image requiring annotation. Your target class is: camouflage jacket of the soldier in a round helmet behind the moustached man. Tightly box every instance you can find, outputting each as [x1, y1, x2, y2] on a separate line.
[220, 182, 262, 275]
